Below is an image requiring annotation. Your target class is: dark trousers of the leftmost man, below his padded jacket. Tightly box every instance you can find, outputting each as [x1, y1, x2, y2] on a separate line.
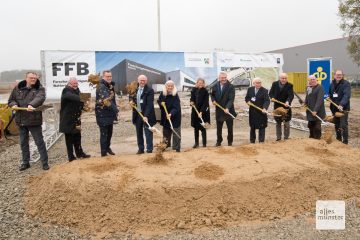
[19, 125, 48, 165]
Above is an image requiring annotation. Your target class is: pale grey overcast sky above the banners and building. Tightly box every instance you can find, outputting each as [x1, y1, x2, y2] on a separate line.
[0, 0, 342, 71]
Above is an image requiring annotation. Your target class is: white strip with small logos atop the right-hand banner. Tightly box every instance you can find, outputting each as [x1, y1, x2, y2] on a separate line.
[216, 52, 284, 69]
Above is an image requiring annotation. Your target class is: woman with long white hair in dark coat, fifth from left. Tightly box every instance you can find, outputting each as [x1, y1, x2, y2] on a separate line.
[157, 80, 181, 152]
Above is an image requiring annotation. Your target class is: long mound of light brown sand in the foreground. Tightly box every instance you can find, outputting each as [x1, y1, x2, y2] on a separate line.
[25, 139, 360, 236]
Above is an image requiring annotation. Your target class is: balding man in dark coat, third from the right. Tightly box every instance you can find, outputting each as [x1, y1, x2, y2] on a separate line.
[269, 73, 294, 141]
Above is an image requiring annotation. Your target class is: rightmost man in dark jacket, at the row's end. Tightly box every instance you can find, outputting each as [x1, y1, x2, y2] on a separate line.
[329, 70, 351, 144]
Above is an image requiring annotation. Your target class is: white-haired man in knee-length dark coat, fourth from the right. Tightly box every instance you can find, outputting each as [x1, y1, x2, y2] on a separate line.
[245, 78, 270, 143]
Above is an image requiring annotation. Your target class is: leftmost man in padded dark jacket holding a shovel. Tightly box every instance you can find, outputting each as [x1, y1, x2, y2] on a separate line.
[8, 72, 49, 171]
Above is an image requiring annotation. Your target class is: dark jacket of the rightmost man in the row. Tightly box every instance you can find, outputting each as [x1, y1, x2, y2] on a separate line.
[329, 79, 351, 114]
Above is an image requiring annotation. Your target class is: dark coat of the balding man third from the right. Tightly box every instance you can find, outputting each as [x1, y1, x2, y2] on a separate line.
[269, 81, 294, 122]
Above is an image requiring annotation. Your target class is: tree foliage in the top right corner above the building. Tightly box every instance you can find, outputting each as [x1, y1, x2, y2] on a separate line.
[339, 0, 360, 66]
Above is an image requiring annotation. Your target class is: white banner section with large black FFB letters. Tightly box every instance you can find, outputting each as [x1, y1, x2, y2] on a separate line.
[41, 51, 96, 99]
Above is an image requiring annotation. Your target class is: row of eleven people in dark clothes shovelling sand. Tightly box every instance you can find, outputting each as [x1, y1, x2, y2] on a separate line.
[8, 70, 351, 171]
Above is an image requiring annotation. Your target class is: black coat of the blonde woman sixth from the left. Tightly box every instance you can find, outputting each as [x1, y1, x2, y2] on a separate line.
[190, 88, 210, 128]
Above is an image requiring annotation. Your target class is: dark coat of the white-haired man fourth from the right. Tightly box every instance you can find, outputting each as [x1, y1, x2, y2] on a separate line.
[245, 87, 270, 129]
